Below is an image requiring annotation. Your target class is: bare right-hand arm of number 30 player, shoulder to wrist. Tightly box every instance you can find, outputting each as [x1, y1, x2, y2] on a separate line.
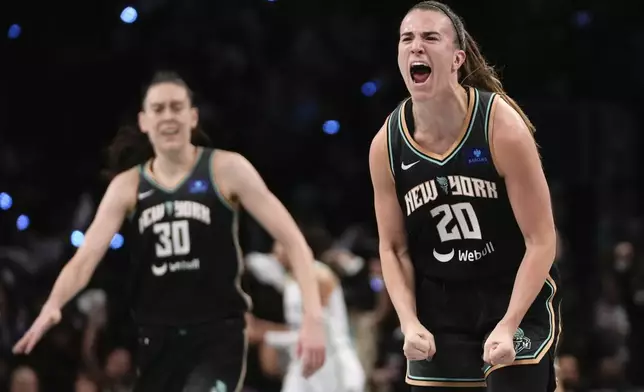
[214, 151, 322, 319]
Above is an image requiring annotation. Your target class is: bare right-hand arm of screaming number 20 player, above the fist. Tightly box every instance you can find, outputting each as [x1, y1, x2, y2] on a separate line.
[490, 98, 556, 331]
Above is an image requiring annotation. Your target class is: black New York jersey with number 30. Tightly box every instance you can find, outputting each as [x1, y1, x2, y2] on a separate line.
[130, 148, 250, 325]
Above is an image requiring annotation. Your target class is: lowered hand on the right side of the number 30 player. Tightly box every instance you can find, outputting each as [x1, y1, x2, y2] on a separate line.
[297, 316, 326, 378]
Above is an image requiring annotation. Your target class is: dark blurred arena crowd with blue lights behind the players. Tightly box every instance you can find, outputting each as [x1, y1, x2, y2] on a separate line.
[0, 0, 644, 392]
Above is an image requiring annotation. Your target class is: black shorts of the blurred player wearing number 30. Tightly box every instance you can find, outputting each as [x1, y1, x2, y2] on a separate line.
[134, 319, 247, 392]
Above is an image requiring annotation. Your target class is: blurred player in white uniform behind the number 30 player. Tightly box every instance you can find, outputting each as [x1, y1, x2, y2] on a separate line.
[250, 242, 365, 392]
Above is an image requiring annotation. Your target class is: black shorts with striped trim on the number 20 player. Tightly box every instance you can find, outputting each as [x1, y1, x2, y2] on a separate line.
[406, 269, 561, 392]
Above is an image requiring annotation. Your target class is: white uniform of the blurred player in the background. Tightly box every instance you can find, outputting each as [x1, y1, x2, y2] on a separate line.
[265, 263, 365, 392]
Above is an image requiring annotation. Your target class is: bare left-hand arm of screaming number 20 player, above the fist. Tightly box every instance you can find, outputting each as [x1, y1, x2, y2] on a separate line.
[369, 126, 418, 331]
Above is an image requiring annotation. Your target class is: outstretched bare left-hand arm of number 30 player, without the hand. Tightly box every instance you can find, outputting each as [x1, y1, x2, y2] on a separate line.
[45, 170, 138, 309]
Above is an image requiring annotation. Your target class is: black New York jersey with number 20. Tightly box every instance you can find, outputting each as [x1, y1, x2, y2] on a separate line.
[387, 88, 525, 281]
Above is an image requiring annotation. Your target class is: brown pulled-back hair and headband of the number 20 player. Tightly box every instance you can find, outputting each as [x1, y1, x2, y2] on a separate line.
[407, 0, 535, 133]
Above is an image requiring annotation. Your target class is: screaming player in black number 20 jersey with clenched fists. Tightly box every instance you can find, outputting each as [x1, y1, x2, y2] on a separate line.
[370, 1, 559, 392]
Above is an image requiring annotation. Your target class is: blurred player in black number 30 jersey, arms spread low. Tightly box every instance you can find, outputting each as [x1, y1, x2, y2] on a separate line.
[13, 73, 325, 392]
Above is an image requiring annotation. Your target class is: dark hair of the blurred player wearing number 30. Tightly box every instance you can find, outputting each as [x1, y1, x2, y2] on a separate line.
[104, 71, 211, 179]
